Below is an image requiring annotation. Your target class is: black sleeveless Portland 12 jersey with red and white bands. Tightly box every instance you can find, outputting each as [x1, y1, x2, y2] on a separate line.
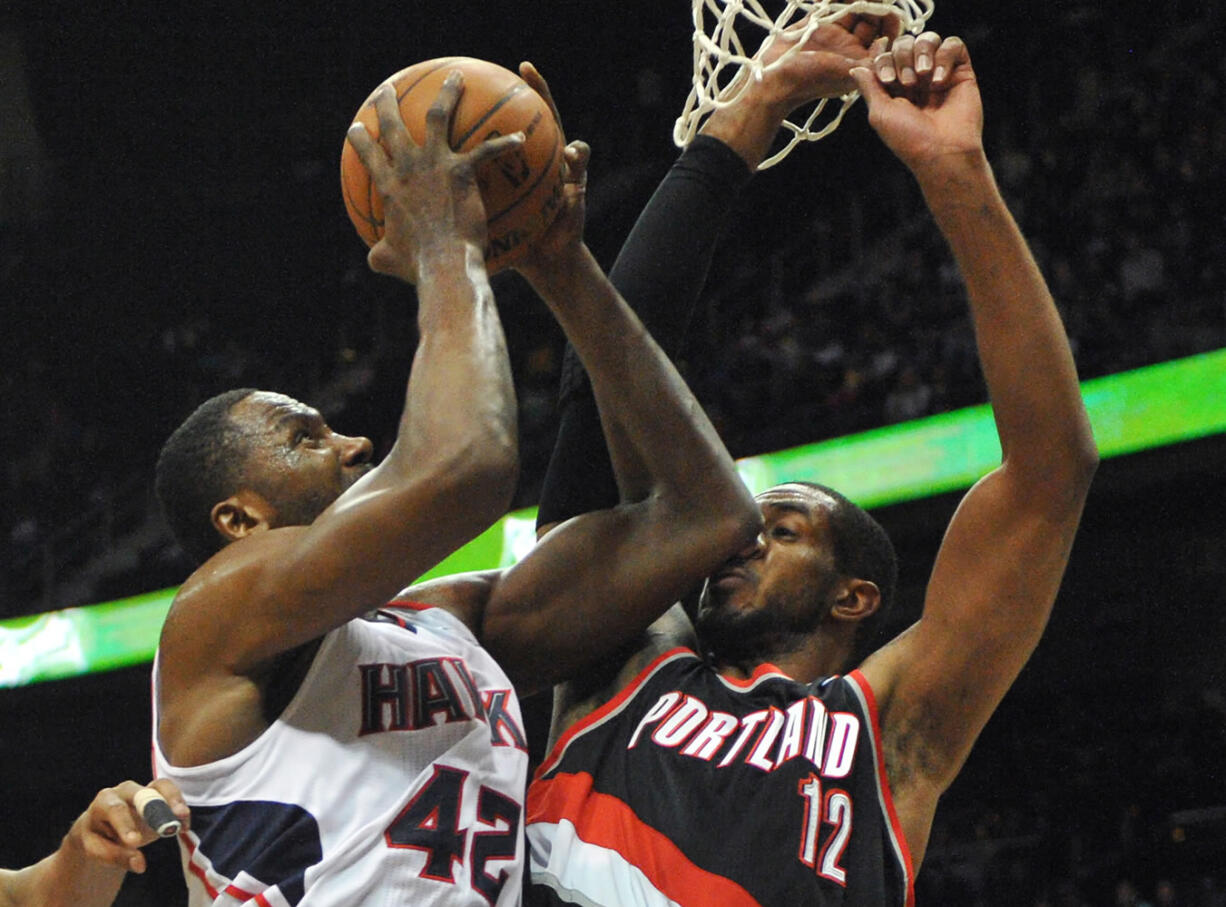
[527, 648, 915, 907]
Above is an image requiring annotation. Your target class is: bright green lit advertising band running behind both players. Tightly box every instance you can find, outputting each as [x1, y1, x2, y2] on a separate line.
[0, 349, 1226, 686]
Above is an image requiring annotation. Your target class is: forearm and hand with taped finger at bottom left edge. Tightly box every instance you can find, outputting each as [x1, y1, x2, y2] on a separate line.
[0, 778, 190, 907]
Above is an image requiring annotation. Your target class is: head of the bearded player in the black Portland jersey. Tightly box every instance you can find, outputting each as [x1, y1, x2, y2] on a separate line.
[698, 482, 897, 659]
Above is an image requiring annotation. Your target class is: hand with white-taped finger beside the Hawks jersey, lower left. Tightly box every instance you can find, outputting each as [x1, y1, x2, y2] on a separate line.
[65, 778, 190, 873]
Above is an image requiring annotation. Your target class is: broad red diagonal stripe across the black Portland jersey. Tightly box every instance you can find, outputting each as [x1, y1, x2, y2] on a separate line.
[527, 772, 758, 907]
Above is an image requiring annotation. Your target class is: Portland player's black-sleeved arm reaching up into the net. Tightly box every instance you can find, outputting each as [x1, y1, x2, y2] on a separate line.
[534, 16, 896, 528]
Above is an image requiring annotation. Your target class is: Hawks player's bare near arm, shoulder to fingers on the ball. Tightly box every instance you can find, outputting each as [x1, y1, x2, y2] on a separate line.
[159, 74, 520, 761]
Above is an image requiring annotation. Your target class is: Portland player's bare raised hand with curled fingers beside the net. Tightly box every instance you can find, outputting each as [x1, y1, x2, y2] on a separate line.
[852, 32, 983, 175]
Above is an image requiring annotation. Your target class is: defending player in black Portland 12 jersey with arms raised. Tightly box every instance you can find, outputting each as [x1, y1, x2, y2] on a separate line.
[528, 33, 1097, 907]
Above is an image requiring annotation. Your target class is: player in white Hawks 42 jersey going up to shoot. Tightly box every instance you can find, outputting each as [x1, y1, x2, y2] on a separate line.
[153, 67, 760, 907]
